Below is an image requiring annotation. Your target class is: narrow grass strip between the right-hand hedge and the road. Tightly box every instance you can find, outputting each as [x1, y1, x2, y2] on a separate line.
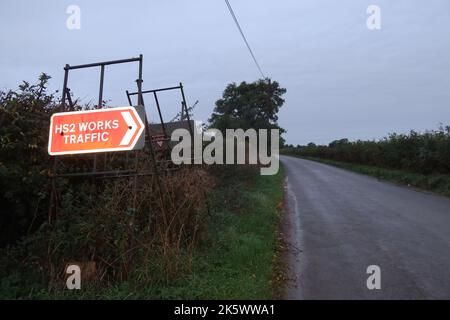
[290, 156, 450, 197]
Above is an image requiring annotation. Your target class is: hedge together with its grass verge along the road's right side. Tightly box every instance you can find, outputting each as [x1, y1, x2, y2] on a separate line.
[282, 126, 450, 196]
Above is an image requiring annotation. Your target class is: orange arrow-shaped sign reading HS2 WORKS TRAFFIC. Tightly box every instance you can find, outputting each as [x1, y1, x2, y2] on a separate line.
[48, 107, 144, 155]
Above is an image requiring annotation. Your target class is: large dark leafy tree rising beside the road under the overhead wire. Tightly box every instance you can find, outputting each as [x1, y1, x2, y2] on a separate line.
[209, 79, 286, 133]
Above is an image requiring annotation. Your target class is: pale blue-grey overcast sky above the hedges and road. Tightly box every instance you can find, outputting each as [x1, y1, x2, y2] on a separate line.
[0, 0, 450, 144]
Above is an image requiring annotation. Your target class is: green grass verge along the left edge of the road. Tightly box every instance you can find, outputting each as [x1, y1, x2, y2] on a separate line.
[156, 168, 284, 299]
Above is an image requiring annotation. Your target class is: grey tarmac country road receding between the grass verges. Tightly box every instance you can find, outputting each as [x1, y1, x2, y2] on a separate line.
[280, 156, 450, 299]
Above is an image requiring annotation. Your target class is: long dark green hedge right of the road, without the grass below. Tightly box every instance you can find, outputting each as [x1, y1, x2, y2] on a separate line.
[282, 125, 450, 174]
